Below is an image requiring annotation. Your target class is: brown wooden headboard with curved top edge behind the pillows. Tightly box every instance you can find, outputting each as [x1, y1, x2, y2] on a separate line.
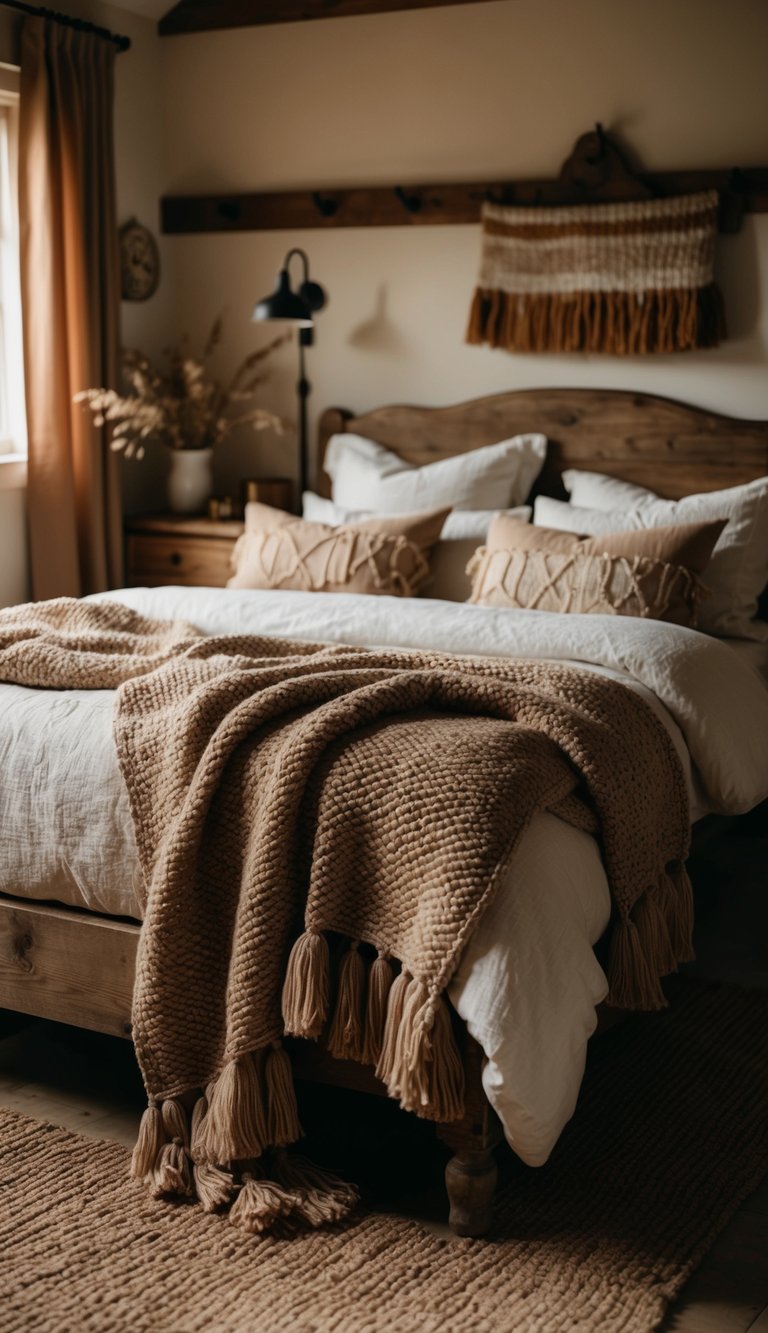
[317, 389, 768, 500]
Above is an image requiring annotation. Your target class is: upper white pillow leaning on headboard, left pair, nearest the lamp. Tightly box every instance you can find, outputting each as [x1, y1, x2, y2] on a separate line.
[324, 435, 547, 515]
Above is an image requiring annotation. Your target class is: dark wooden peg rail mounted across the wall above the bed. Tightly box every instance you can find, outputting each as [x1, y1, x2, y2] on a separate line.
[161, 167, 768, 235]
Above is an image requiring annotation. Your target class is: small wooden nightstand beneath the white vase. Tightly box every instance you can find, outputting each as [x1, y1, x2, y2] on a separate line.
[125, 513, 243, 588]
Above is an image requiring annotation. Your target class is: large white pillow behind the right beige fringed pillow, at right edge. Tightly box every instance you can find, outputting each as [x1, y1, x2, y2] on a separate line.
[533, 487, 768, 643]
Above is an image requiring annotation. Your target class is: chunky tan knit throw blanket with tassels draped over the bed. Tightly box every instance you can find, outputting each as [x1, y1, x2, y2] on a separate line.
[0, 600, 691, 1230]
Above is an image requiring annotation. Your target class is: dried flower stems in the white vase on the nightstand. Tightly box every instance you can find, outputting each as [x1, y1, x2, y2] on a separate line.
[75, 316, 289, 459]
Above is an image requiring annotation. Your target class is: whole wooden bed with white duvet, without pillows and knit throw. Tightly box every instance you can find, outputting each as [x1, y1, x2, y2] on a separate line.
[0, 389, 768, 1236]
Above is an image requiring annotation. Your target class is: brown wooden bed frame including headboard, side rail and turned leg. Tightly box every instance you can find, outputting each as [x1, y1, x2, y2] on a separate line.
[0, 389, 768, 1236]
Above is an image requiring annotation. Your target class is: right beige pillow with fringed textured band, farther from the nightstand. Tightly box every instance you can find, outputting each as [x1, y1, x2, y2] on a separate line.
[467, 516, 724, 628]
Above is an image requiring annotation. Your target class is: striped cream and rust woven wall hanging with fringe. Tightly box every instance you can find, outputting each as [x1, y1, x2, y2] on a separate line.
[467, 191, 725, 356]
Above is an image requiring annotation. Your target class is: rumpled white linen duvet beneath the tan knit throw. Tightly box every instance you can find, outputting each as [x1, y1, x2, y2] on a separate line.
[0, 588, 768, 1165]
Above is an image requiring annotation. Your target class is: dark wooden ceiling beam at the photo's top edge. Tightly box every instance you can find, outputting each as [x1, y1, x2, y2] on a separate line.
[157, 0, 504, 37]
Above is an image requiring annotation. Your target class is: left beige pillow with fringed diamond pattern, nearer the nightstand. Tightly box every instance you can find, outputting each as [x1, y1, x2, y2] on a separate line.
[227, 504, 449, 597]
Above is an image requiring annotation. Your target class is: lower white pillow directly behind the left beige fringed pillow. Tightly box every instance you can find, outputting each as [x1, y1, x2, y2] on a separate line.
[301, 491, 532, 601]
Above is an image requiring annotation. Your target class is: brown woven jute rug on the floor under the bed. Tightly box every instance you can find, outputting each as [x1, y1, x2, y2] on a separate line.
[0, 984, 768, 1333]
